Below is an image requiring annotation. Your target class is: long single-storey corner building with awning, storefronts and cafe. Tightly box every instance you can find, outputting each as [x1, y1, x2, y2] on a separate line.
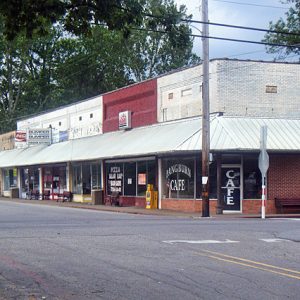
[0, 59, 300, 213]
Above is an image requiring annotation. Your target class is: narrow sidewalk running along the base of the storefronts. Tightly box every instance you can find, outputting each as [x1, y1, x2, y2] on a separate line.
[0, 197, 300, 219]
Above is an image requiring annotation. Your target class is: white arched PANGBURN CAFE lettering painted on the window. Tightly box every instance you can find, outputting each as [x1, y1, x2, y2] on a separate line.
[166, 164, 192, 191]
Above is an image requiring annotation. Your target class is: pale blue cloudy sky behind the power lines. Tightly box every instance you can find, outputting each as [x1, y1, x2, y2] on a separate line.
[174, 0, 297, 61]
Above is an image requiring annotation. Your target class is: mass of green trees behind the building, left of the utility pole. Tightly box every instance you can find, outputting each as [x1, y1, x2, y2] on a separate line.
[0, 0, 199, 132]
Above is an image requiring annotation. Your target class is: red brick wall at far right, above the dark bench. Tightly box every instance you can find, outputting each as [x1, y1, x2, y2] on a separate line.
[267, 154, 300, 200]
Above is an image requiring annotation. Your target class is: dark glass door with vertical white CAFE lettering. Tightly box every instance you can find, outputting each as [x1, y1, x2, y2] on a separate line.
[221, 165, 242, 212]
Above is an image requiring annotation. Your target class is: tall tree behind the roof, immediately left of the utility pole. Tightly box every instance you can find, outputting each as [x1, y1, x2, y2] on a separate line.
[124, 0, 200, 81]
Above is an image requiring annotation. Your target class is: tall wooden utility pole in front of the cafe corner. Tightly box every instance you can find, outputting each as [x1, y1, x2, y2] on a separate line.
[202, 0, 210, 217]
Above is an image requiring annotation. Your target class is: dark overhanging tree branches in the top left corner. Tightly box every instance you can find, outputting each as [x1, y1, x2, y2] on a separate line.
[0, 0, 145, 40]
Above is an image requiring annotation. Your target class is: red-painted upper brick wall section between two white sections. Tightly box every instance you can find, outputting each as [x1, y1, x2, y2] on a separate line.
[103, 79, 157, 132]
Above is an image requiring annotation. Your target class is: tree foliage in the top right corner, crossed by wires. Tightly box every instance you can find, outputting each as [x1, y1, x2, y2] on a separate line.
[263, 0, 300, 56]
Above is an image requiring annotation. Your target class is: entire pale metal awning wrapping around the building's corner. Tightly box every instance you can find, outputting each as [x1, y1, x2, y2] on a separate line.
[0, 116, 300, 168]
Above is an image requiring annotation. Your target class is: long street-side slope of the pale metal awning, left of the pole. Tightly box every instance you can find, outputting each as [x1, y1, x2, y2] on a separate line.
[0, 118, 200, 168]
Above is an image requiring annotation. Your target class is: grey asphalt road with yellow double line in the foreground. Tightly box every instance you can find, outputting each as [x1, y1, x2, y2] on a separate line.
[0, 201, 300, 300]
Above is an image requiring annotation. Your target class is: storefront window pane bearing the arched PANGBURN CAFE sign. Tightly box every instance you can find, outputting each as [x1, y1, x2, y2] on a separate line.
[163, 158, 195, 199]
